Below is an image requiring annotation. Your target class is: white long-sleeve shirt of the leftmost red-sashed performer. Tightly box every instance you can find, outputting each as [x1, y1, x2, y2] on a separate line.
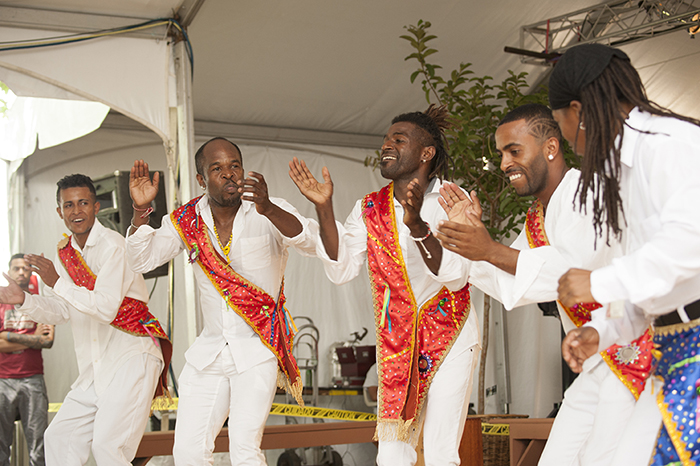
[19, 220, 163, 394]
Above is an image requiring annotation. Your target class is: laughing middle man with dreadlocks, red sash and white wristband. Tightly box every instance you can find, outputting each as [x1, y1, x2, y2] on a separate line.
[290, 105, 480, 466]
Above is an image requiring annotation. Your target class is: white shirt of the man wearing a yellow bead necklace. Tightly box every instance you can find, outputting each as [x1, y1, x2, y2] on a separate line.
[126, 195, 316, 372]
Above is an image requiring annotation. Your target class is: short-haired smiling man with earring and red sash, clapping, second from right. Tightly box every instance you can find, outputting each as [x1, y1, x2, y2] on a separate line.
[438, 104, 653, 466]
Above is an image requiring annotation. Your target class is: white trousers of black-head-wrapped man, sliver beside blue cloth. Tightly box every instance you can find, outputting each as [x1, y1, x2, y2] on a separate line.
[610, 379, 662, 466]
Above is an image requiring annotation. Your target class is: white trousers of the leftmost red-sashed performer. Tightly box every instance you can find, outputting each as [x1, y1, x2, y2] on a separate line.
[44, 354, 163, 466]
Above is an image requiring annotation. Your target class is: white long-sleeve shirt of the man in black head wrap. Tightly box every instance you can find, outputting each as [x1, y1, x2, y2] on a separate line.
[590, 108, 700, 347]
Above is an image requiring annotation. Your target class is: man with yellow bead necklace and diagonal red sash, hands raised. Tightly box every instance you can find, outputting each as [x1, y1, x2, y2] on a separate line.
[127, 138, 315, 466]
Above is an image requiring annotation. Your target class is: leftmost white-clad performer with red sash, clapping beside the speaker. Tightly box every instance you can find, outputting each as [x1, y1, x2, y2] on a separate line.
[0, 175, 171, 466]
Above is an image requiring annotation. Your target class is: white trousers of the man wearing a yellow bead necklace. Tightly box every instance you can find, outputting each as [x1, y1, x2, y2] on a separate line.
[173, 345, 277, 466]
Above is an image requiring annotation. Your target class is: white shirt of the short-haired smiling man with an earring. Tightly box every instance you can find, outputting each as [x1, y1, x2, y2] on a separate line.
[469, 169, 622, 332]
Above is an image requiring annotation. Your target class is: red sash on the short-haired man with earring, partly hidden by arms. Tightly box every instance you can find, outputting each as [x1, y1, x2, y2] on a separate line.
[525, 200, 654, 399]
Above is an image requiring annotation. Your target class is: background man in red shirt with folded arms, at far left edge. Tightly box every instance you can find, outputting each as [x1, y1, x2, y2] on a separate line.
[0, 254, 54, 466]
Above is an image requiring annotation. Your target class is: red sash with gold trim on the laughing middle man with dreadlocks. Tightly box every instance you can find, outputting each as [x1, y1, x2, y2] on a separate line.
[362, 183, 471, 441]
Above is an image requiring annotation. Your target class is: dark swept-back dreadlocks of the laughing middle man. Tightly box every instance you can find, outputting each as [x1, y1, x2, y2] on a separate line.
[391, 104, 452, 181]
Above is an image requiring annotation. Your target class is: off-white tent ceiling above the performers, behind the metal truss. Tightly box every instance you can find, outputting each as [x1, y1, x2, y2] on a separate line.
[0, 0, 700, 144]
